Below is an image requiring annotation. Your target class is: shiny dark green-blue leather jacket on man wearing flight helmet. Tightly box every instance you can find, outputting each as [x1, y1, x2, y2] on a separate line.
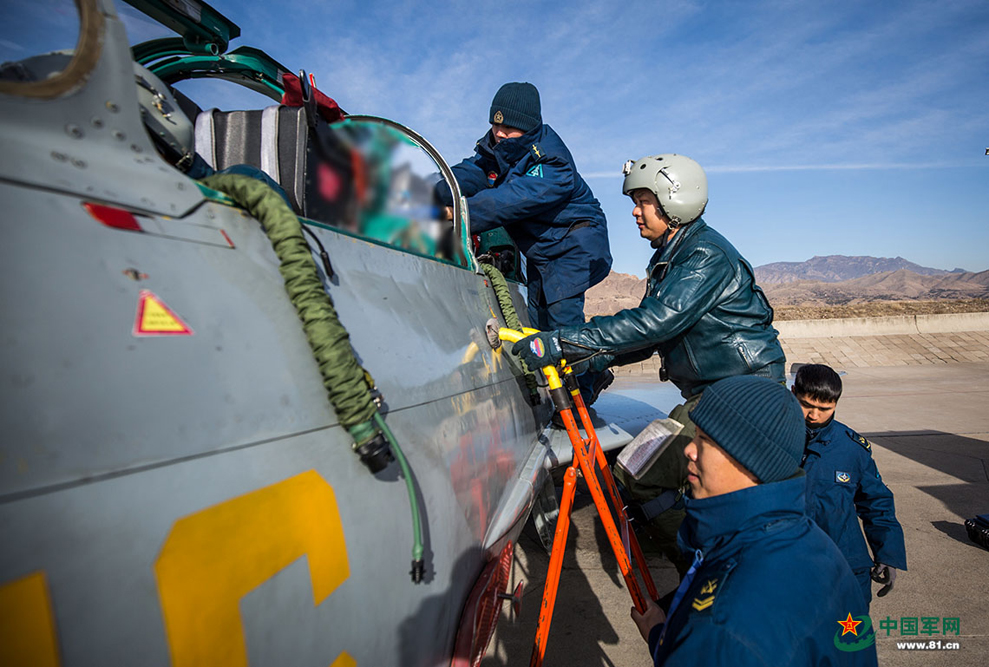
[560, 219, 785, 398]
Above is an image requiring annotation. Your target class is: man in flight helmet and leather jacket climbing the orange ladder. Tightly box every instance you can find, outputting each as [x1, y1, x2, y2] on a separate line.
[513, 153, 786, 576]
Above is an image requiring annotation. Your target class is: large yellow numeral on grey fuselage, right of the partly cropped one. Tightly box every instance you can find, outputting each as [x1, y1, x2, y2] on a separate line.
[155, 470, 357, 667]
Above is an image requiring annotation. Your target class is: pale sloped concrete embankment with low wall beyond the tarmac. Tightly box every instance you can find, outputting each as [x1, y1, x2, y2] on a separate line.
[613, 313, 989, 375]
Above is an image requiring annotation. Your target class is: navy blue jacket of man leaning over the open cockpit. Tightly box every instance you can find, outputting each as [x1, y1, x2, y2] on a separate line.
[436, 125, 611, 304]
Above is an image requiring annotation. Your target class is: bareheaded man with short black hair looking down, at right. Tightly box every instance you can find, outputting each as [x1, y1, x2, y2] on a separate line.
[793, 364, 907, 605]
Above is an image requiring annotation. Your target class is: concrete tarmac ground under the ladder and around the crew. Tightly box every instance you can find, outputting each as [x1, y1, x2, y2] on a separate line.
[481, 363, 989, 667]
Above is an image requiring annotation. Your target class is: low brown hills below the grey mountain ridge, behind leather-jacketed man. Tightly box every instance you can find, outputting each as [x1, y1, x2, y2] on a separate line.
[584, 268, 989, 317]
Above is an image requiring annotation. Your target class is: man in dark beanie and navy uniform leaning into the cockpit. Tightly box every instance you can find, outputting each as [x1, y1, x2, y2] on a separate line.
[436, 82, 613, 402]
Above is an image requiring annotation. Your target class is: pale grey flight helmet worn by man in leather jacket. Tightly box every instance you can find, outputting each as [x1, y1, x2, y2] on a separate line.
[622, 153, 707, 229]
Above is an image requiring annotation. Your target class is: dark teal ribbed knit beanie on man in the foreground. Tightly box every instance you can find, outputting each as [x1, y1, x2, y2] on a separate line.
[690, 375, 805, 482]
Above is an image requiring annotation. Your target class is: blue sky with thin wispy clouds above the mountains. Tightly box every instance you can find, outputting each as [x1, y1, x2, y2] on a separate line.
[9, 0, 989, 275]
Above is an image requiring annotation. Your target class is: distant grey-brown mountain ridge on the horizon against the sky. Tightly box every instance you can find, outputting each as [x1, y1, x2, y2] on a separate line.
[755, 255, 965, 286]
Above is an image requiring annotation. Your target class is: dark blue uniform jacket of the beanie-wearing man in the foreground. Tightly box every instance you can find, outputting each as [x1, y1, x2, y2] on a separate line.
[649, 473, 876, 667]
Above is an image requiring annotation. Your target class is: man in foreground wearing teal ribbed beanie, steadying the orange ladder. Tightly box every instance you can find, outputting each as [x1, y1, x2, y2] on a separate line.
[632, 376, 876, 667]
